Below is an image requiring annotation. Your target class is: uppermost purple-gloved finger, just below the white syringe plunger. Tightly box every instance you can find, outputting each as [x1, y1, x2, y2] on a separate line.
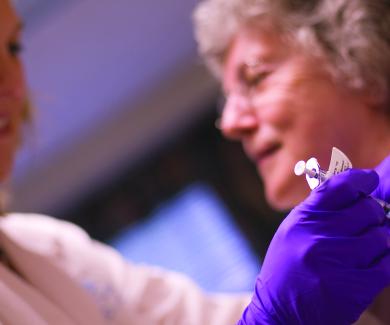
[305, 169, 379, 210]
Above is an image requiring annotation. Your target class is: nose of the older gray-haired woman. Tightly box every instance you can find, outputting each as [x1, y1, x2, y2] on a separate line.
[219, 95, 258, 140]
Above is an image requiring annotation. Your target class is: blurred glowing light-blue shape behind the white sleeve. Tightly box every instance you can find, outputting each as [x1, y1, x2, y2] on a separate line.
[110, 184, 260, 292]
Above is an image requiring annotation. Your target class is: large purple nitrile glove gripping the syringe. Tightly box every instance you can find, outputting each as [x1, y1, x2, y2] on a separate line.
[238, 169, 390, 325]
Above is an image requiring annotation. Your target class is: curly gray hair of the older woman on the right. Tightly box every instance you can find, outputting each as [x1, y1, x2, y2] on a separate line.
[194, 0, 390, 110]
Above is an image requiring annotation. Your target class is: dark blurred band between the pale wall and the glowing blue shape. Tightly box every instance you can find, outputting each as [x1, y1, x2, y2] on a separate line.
[60, 105, 284, 257]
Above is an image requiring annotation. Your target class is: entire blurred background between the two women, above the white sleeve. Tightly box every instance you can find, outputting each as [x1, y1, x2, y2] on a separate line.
[10, 0, 282, 291]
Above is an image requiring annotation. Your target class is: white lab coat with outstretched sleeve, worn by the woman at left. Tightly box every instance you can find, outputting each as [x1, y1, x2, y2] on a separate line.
[0, 214, 250, 325]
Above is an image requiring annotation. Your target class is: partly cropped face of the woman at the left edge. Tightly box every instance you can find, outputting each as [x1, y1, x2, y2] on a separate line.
[0, 0, 26, 181]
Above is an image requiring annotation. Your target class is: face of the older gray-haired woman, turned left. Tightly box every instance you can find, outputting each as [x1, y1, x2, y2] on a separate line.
[221, 29, 386, 209]
